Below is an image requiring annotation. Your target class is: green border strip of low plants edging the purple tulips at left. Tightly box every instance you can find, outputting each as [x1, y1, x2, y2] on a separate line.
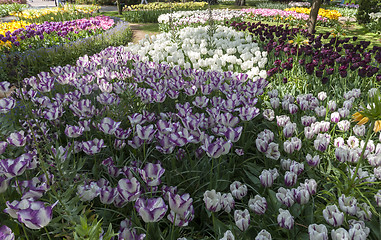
[0, 19, 132, 82]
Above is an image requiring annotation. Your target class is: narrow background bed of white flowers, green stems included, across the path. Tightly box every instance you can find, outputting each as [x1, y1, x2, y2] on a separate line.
[158, 9, 245, 32]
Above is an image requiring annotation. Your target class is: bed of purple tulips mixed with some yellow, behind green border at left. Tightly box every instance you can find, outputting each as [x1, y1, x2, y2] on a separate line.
[0, 16, 114, 52]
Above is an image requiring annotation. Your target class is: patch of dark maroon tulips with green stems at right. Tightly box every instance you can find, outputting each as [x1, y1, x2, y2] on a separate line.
[230, 22, 381, 94]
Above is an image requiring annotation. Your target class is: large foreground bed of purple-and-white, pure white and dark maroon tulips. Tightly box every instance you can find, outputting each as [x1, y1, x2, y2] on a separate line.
[0, 4, 381, 240]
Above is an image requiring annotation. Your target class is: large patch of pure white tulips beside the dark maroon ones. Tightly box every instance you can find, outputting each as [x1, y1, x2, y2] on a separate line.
[125, 26, 267, 80]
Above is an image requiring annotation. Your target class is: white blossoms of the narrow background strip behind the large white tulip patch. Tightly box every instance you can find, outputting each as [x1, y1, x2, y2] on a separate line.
[158, 9, 245, 26]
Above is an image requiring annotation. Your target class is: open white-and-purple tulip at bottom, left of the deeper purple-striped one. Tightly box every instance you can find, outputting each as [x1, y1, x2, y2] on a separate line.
[135, 197, 168, 223]
